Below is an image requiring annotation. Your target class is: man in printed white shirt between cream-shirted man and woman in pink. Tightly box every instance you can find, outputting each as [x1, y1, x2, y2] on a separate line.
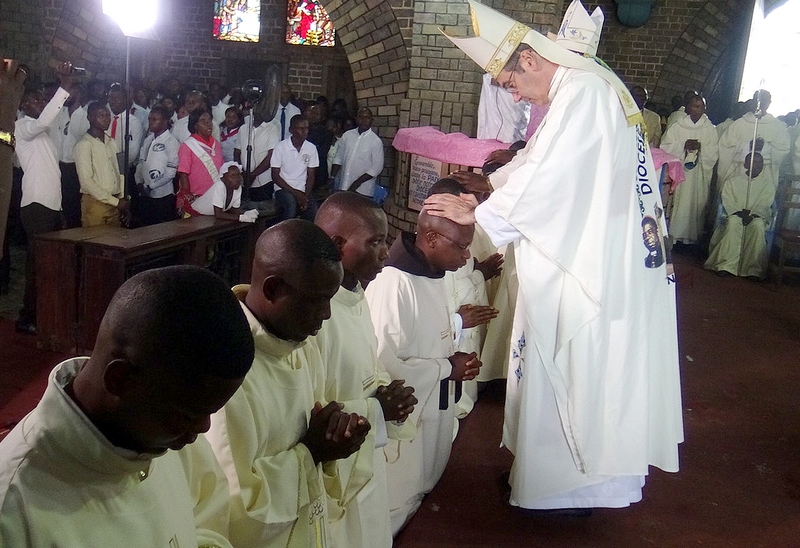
[135, 105, 180, 226]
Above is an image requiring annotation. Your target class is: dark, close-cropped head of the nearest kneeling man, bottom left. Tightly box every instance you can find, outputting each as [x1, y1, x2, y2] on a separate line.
[72, 266, 254, 454]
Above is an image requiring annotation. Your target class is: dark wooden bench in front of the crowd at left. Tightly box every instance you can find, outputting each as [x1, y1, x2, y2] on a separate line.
[36, 216, 257, 352]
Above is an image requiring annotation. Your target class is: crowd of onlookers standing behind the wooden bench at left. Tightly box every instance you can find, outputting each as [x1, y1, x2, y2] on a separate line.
[0, 63, 383, 333]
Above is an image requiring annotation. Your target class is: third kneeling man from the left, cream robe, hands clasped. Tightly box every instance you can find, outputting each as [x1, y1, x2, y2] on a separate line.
[314, 192, 417, 548]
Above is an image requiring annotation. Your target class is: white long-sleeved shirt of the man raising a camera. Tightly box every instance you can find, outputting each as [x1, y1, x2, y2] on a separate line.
[14, 88, 69, 211]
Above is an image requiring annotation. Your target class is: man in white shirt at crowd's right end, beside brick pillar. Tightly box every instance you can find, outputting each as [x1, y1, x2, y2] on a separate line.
[330, 108, 383, 198]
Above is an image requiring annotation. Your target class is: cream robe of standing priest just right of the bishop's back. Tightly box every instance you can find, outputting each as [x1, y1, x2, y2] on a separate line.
[661, 114, 719, 244]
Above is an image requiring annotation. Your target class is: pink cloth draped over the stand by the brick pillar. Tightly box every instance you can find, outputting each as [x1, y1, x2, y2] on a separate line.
[392, 126, 508, 167]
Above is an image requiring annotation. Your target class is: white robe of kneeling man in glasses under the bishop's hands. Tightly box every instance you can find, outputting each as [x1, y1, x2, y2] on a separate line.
[366, 233, 455, 533]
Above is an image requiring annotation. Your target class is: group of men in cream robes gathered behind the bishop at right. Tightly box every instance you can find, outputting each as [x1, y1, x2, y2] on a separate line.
[643, 89, 800, 280]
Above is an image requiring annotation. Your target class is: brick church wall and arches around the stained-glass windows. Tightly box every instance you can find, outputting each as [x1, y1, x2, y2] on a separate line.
[0, 0, 752, 233]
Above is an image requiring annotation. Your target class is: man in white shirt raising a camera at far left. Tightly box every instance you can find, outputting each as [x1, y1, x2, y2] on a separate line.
[14, 63, 72, 333]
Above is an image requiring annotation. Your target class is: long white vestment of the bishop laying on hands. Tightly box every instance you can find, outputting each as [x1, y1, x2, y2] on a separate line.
[476, 67, 683, 509]
